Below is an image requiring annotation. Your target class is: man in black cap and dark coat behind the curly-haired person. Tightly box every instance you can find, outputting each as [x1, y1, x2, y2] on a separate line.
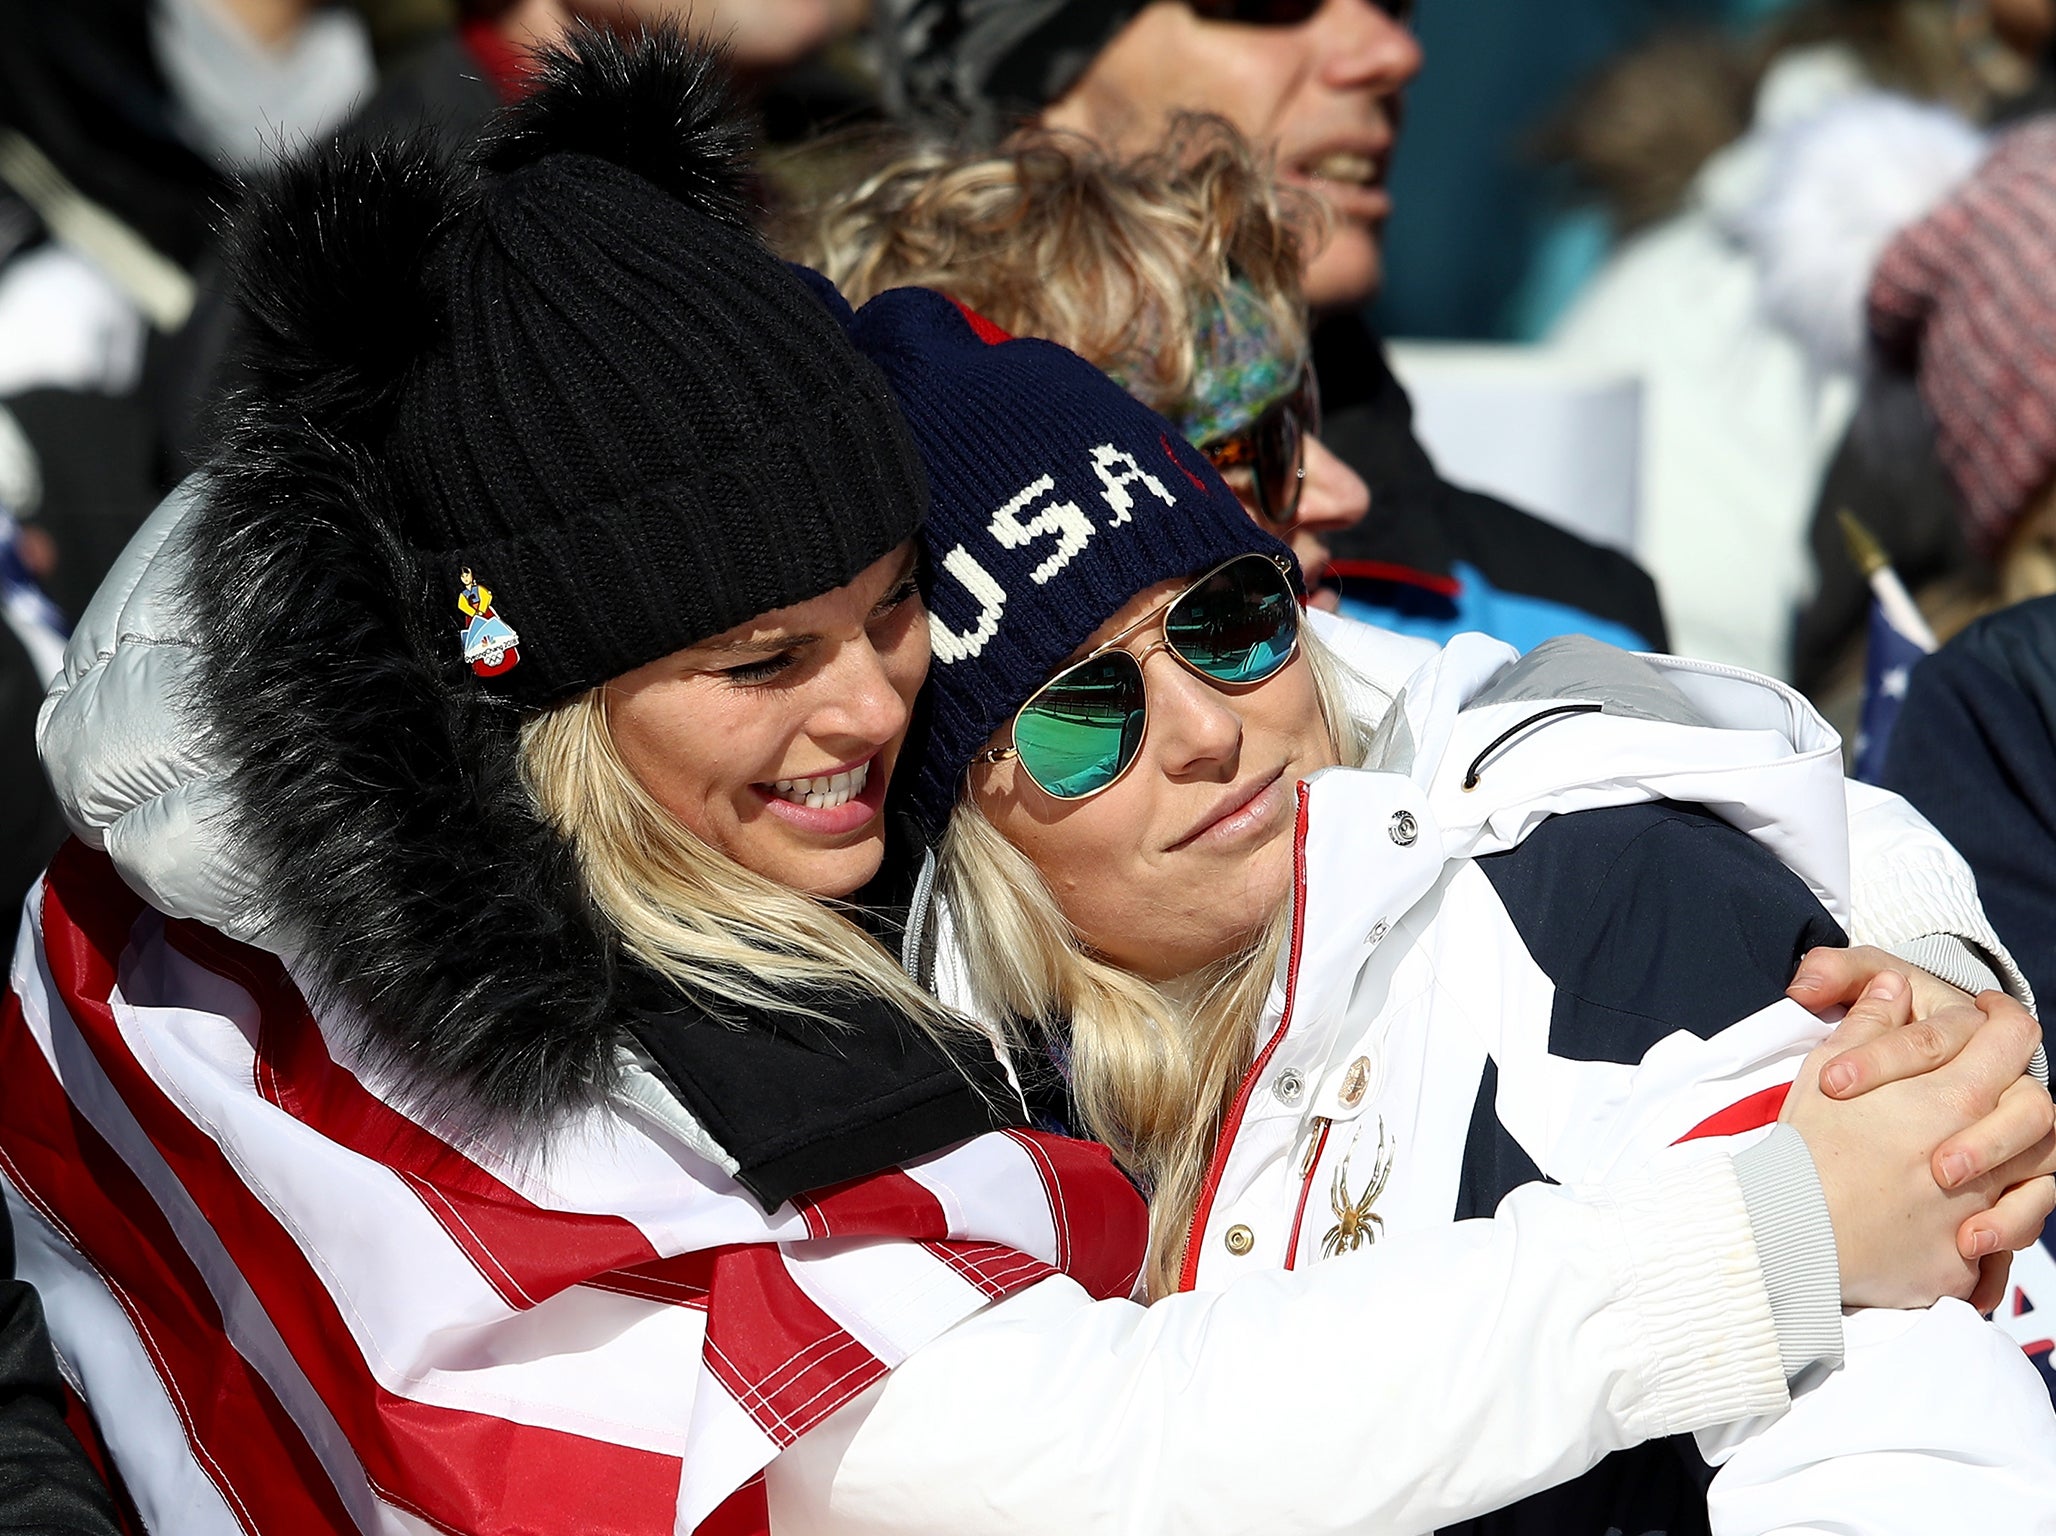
[878, 0, 1669, 650]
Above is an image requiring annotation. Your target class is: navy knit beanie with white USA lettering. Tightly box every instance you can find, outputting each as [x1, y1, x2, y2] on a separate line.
[820, 284, 1297, 835]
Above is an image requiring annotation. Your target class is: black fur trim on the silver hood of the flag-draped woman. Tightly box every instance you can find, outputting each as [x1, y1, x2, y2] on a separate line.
[172, 24, 1023, 1205]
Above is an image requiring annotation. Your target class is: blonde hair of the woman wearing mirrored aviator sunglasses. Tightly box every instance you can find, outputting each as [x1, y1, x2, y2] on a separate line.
[940, 625, 1365, 1297]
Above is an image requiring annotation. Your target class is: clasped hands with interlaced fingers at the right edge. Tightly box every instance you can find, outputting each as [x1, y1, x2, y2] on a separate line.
[1780, 978, 2056, 1308]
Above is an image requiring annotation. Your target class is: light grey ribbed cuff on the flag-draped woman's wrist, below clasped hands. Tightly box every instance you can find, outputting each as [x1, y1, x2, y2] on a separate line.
[1735, 1126, 1850, 1382]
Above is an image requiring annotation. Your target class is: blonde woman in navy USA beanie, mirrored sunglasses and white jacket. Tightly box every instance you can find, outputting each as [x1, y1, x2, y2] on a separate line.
[802, 290, 2056, 1536]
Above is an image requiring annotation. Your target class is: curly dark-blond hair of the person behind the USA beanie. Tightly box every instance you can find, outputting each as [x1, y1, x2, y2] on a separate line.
[798, 115, 1322, 411]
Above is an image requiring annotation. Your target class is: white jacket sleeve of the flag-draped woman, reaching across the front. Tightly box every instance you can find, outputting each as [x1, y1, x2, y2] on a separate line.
[767, 1149, 1787, 1536]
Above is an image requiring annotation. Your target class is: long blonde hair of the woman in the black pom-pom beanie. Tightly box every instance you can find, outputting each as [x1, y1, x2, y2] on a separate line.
[520, 687, 989, 1040]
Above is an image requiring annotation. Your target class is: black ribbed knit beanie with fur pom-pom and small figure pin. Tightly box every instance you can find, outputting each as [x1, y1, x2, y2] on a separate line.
[233, 31, 925, 705]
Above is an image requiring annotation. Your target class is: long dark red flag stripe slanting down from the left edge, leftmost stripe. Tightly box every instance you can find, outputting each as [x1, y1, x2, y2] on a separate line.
[0, 993, 358, 1536]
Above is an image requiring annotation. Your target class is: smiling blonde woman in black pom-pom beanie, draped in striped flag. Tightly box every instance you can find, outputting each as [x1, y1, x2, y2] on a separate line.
[12, 24, 2056, 1536]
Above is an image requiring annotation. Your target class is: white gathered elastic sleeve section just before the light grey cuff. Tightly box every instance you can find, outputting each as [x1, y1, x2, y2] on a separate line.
[1589, 1158, 1791, 1439]
